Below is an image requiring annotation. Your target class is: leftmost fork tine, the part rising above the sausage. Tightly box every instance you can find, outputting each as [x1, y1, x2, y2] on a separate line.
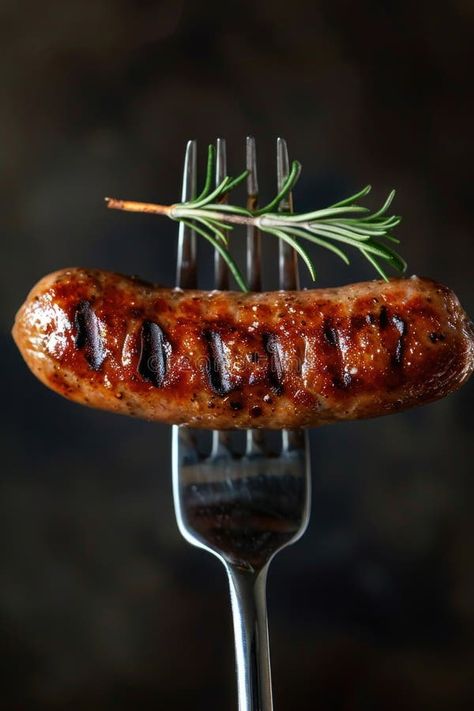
[176, 140, 197, 289]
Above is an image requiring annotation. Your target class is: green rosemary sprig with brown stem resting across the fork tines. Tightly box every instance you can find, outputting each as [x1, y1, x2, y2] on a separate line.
[106, 146, 407, 291]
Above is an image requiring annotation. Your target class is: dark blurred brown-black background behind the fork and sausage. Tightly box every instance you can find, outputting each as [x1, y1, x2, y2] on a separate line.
[0, 0, 474, 711]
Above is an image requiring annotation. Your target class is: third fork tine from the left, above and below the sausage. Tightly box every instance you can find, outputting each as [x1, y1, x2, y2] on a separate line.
[245, 136, 263, 457]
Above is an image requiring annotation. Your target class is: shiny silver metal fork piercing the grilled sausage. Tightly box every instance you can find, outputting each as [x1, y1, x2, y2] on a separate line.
[172, 137, 310, 711]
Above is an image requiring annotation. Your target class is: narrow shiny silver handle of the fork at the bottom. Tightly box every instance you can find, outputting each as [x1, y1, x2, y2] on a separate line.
[226, 565, 273, 711]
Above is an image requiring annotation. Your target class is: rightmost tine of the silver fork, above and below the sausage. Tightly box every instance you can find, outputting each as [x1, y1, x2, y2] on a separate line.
[277, 138, 307, 453]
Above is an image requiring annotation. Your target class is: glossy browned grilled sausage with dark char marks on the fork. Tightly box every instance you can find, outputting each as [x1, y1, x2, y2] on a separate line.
[13, 269, 474, 429]
